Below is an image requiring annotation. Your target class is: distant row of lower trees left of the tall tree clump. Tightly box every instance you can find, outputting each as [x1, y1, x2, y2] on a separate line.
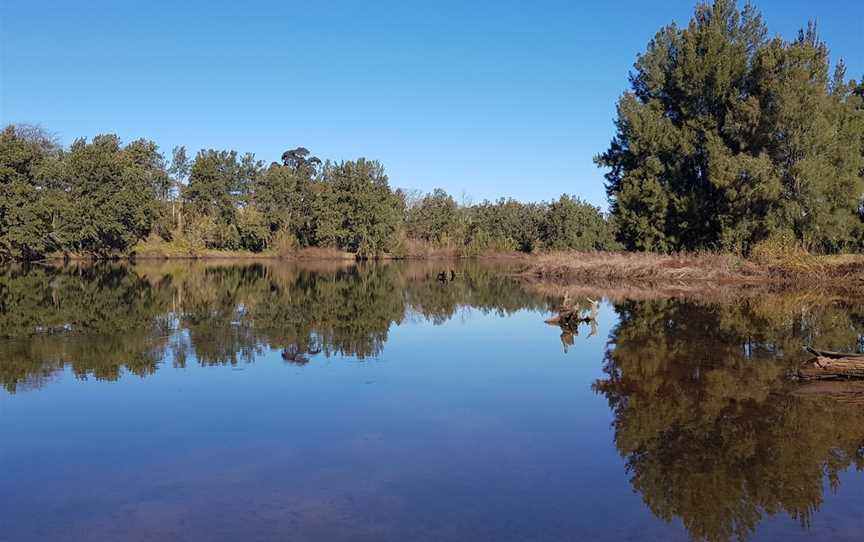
[0, 125, 615, 260]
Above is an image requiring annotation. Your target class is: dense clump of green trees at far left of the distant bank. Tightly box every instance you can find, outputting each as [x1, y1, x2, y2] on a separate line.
[0, 126, 167, 259]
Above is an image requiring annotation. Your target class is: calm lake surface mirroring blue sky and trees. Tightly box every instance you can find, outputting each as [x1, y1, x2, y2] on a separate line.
[0, 263, 864, 542]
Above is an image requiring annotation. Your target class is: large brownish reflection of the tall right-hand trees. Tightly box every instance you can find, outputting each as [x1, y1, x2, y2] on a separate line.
[594, 296, 864, 541]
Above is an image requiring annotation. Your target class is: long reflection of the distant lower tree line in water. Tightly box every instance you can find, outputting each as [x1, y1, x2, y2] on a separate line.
[0, 262, 551, 392]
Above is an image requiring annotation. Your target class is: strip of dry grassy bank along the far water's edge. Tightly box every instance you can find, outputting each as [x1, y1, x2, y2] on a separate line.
[8, 248, 864, 292]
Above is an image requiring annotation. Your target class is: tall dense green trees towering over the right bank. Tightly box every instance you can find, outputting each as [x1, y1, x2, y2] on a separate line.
[597, 0, 864, 253]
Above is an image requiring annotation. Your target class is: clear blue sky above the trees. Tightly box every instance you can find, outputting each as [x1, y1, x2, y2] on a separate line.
[0, 0, 864, 204]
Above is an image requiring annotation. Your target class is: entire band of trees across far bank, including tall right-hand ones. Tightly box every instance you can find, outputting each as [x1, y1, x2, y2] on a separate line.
[0, 0, 864, 259]
